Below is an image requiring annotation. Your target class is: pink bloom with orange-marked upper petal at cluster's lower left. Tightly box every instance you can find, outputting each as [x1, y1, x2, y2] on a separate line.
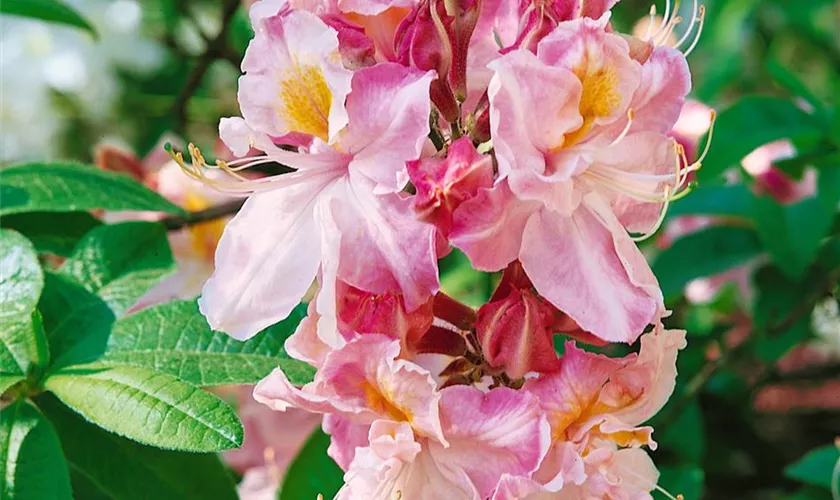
[254, 335, 548, 500]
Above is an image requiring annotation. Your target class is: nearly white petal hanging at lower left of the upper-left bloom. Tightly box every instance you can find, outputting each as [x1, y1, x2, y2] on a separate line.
[198, 175, 328, 340]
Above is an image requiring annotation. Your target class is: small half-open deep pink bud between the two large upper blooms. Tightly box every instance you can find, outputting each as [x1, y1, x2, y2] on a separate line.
[408, 137, 493, 235]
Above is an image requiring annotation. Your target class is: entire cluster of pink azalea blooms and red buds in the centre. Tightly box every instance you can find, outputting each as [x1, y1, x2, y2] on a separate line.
[174, 0, 703, 494]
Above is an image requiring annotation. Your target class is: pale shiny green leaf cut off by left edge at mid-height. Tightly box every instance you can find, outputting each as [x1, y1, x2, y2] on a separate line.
[0, 229, 46, 375]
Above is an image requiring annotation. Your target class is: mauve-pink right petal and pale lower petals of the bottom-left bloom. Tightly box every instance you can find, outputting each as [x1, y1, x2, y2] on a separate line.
[337, 386, 548, 500]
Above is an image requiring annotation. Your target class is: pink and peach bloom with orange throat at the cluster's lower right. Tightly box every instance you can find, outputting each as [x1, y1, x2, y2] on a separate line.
[523, 327, 685, 489]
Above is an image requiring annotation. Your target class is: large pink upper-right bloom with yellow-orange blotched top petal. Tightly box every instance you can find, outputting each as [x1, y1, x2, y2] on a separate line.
[451, 16, 689, 342]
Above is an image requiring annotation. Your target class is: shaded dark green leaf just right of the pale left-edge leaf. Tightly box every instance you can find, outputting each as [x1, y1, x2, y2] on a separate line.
[38, 271, 116, 368]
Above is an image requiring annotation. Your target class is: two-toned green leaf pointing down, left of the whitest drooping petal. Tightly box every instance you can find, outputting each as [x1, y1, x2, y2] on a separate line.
[60, 221, 175, 316]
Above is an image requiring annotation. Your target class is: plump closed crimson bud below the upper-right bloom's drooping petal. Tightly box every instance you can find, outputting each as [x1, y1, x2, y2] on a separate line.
[476, 289, 559, 379]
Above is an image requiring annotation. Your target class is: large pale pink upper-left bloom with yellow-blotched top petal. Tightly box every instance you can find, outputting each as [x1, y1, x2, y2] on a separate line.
[184, 4, 438, 346]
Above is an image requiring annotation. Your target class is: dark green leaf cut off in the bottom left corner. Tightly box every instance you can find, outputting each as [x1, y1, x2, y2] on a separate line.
[0, 401, 73, 500]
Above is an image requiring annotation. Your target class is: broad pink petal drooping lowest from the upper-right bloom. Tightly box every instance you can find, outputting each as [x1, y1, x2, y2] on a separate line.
[520, 194, 661, 342]
